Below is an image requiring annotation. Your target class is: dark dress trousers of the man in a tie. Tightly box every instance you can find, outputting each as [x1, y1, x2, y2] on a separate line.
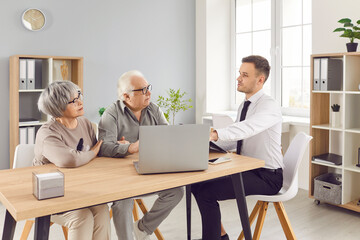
[191, 169, 283, 240]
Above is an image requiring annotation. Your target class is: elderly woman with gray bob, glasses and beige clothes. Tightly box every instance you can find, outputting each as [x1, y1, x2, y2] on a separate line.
[33, 81, 110, 240]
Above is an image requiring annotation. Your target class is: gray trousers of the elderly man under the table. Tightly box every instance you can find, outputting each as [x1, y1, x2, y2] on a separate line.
[111, 187, 184, 240]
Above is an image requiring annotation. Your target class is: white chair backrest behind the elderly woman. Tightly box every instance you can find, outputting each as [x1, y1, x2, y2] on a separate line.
[13, 144, 35, 168]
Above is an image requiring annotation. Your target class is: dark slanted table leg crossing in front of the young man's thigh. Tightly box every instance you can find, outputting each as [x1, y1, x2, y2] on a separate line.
[231, 173, 252, 240]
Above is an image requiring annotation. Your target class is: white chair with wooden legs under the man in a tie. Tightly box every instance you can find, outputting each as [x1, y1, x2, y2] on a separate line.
[238, 132, 312, 240]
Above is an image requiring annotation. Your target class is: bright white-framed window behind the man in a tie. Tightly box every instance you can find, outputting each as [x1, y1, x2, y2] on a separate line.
[232, 0, 311, 116]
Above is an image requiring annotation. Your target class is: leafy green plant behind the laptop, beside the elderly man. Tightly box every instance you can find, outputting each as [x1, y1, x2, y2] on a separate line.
[156, 88, 192, 125]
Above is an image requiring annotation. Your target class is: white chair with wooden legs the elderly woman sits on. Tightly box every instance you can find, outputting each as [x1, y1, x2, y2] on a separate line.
[13, 144, 68, 240]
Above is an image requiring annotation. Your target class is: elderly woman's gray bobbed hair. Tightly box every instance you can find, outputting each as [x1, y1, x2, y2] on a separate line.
[38, 81, 80, 118]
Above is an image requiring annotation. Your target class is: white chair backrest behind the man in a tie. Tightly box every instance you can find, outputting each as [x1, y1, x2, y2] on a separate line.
[283, 132, 312, 195]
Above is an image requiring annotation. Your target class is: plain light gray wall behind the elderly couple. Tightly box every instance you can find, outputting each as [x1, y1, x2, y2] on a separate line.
[0, 0, 195, 169]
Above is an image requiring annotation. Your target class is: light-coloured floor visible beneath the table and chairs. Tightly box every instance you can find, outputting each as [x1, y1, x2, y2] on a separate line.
[0, 190, 360, 240]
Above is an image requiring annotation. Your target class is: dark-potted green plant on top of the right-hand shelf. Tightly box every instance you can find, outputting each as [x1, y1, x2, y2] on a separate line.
[334, 18, 360, 52]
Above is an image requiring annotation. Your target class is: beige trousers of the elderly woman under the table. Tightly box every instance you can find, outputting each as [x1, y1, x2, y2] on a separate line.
[51, 204, 111, 240]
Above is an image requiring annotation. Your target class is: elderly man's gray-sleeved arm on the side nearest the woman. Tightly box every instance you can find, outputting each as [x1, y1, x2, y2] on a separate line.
[99, 107, 130, 158]
